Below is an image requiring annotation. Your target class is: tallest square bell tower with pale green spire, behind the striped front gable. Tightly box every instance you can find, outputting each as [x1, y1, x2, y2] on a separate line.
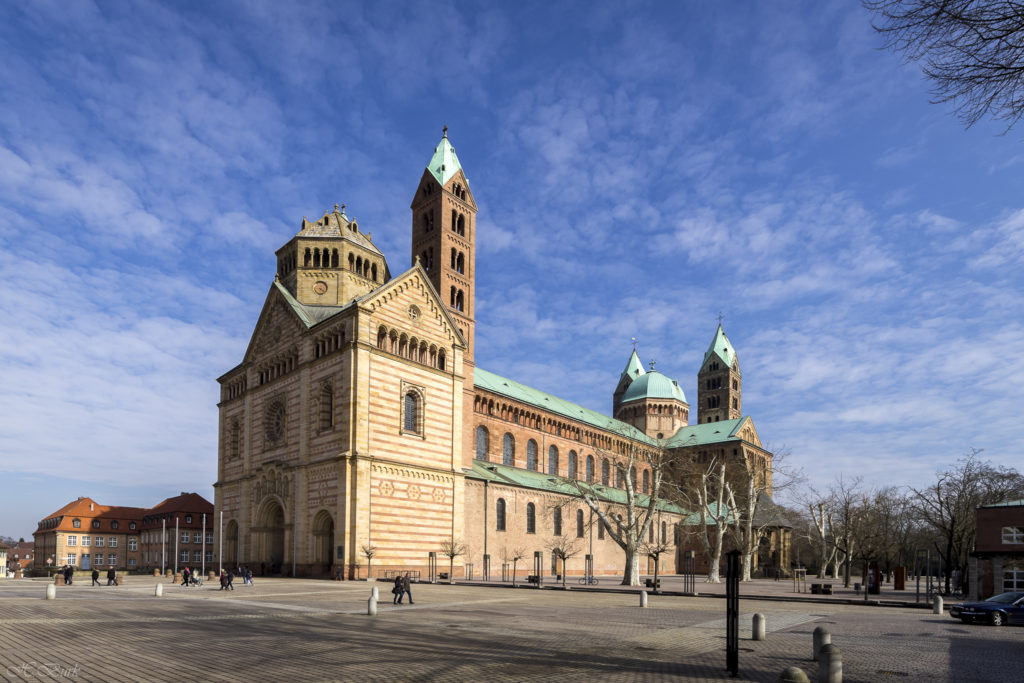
[411, 126, 476, 367]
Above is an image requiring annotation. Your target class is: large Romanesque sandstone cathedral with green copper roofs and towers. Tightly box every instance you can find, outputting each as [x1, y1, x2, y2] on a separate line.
[214, 129, 788, 579]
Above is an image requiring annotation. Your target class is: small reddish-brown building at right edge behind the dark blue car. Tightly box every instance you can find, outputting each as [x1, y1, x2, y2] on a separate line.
[970, 500, 1024, 600]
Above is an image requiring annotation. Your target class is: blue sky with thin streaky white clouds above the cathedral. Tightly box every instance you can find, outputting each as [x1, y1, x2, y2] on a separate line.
[0, 0, 1024, 538]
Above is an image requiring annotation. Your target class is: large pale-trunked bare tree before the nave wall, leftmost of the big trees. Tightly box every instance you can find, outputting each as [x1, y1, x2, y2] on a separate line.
[568, 427, 672, 586]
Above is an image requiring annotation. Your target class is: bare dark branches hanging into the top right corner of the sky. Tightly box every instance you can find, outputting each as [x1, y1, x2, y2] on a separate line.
[863, 0, 1024, 130]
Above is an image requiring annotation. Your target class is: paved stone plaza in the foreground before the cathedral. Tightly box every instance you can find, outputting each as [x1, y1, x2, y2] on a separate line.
[0, 577, 1024, 683]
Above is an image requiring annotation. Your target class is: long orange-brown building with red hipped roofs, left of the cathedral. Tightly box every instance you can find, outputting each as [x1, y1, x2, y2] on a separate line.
[33, 493, 213, 571]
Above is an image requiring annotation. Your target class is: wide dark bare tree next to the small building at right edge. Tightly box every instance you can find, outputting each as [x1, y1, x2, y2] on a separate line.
[910, 449, 1024, 593]
